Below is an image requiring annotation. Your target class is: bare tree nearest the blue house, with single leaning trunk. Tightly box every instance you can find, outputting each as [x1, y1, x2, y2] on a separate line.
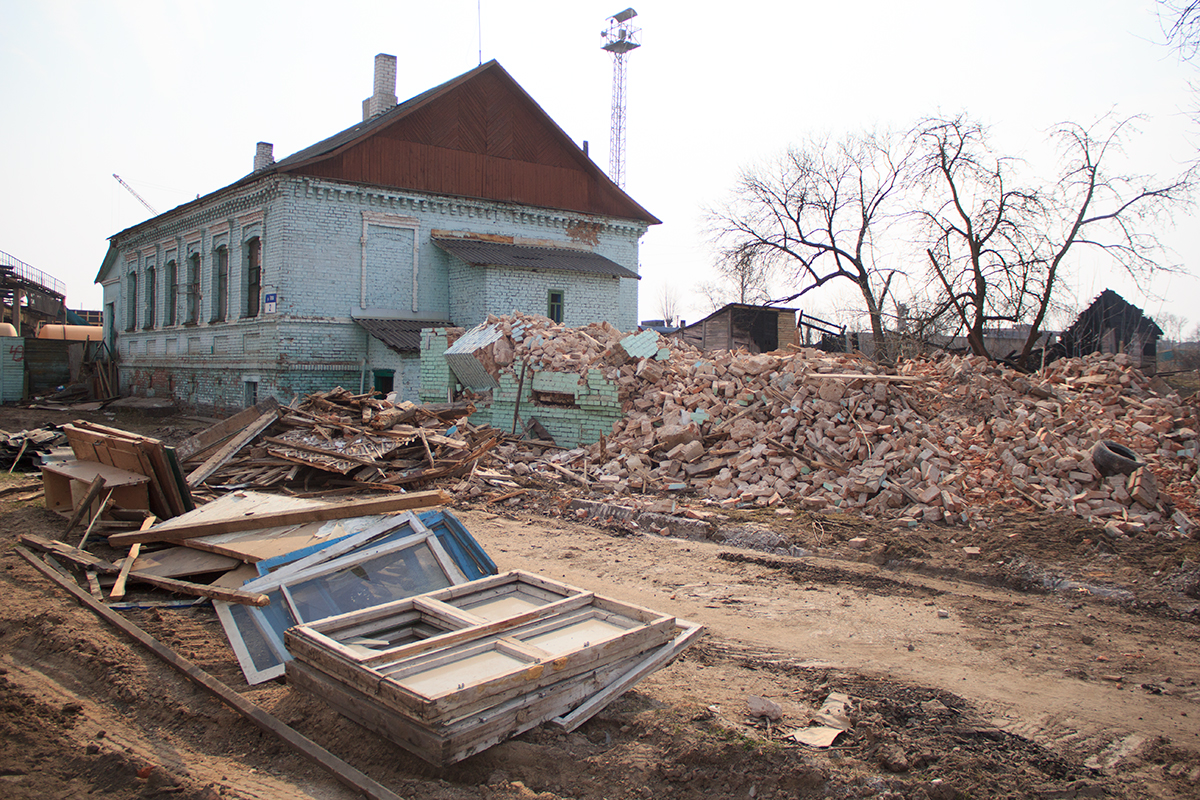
[709, 134, 908, 347]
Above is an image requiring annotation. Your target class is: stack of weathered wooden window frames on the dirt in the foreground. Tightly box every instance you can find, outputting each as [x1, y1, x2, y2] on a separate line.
[286, 572, 703, 766]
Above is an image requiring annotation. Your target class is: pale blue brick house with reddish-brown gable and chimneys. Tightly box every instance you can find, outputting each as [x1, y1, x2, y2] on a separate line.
[96, 54, 659, 409]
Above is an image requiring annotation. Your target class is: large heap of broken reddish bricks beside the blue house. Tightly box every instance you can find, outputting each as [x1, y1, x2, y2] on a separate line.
[448, 314, 1200, 534]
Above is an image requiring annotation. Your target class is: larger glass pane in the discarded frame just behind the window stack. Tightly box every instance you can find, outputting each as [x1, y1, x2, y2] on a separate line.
[288, 543, 450, 621]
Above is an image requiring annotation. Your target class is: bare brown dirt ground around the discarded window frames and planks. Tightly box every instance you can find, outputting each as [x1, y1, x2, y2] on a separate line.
[0, 408, 1200, 800]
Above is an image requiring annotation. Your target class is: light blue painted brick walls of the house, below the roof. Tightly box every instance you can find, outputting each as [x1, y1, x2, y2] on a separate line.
[104, 176, 644, 412]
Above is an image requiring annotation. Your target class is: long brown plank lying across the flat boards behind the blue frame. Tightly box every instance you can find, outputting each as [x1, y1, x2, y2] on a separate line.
[108, 489, 454, 547]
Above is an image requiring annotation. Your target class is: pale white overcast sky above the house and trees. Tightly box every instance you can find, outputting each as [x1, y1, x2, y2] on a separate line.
[0, 0, 1200, 330]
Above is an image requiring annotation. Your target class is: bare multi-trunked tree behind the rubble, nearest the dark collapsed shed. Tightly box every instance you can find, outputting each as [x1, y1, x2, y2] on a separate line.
[916, 116, 1195, 362]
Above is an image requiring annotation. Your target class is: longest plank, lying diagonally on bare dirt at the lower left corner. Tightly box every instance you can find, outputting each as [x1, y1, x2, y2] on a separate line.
[17, 547, 401, 800]
